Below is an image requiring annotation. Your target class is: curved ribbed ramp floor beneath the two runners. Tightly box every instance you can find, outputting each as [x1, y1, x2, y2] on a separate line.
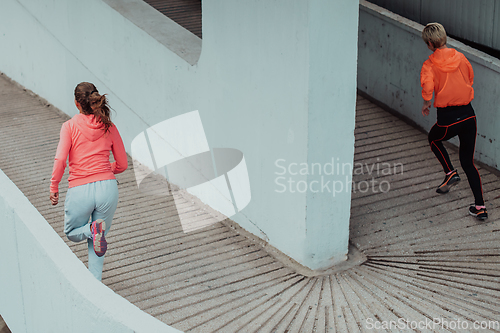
[0, 76, 500, 333]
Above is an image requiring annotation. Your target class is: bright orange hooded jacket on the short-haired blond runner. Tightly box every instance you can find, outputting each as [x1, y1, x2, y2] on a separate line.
[420, 48, 474, 108]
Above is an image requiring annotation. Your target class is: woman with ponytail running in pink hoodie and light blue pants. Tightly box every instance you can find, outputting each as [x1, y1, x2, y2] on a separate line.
[50, 82, 127, 281]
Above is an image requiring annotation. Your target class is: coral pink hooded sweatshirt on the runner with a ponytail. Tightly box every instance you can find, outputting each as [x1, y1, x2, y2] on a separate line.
[50, 114, 128, 193]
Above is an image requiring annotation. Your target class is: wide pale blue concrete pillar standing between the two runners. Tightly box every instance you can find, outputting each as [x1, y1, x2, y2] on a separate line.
[199, 0, 359, 270]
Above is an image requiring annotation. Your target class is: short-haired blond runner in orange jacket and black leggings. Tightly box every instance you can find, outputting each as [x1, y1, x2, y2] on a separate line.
[420, 23, 488, 220]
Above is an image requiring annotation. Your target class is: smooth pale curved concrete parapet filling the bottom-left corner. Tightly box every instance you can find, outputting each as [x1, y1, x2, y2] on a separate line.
[0, 171, 180, 333]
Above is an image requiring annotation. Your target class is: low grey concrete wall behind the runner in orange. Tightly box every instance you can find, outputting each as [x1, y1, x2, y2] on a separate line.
[358, 1, 500, 169]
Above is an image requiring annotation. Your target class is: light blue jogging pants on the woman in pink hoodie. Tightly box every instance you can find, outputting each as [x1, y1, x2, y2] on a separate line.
[64, 179, 118, 281]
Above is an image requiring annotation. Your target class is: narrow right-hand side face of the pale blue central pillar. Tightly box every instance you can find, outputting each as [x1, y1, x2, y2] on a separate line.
[304, 0, 358, 269]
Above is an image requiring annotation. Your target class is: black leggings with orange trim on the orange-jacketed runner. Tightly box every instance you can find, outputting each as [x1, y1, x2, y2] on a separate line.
[429, 116, 484, 206]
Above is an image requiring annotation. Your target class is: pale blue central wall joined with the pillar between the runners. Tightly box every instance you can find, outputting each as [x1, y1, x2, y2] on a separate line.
[0, 0, 358, 269]
